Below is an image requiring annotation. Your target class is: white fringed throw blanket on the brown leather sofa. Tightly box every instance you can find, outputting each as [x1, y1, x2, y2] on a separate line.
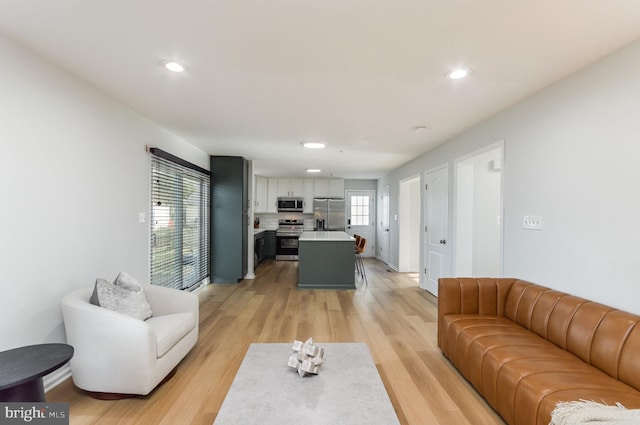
[549, 400, 640, 425]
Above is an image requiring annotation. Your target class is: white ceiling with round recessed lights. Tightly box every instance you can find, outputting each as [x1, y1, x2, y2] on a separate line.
[0, 0, 640, 178]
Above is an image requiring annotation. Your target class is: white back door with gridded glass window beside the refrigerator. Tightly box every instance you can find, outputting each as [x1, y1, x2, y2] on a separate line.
[347, 190, 376, 257]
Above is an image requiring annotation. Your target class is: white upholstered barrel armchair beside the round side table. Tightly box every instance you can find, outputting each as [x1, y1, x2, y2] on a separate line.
[62, 284, 199, 398]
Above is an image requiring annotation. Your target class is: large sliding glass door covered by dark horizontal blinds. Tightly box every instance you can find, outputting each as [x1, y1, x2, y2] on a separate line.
[150, 148, 210, 289]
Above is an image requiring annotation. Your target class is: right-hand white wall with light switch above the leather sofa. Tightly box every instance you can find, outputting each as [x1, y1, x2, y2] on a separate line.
[378, 36, 640, 313]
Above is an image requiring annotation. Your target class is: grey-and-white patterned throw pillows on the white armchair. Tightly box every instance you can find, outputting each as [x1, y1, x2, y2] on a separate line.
[90, 272, 152, 320]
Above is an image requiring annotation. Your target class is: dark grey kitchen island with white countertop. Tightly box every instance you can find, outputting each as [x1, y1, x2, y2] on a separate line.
[298, 231, 356, 289]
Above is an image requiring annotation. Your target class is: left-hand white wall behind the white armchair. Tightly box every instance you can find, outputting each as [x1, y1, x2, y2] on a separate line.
[0, 33, 209, 350]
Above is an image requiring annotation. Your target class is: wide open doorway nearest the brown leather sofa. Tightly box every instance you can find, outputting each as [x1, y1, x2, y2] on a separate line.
[454, 142, 504, 277]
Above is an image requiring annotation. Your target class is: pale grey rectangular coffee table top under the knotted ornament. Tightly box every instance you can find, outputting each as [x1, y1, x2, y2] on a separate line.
[214, 342, 400, 425]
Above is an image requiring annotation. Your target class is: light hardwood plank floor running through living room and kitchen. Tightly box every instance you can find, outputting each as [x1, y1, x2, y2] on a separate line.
[47, 259, 504, 425]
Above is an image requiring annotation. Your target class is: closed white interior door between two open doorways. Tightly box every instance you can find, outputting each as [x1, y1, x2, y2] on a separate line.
[423, 165, 449, 297]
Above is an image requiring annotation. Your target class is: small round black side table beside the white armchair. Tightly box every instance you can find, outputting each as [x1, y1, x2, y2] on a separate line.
[0, 344, 73, 402]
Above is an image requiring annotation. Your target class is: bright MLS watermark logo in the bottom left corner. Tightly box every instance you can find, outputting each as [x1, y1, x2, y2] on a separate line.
[0, 402, 69, 425]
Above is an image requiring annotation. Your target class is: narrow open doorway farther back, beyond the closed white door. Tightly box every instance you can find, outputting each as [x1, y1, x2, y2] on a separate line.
[398, 174, 421, 273]
